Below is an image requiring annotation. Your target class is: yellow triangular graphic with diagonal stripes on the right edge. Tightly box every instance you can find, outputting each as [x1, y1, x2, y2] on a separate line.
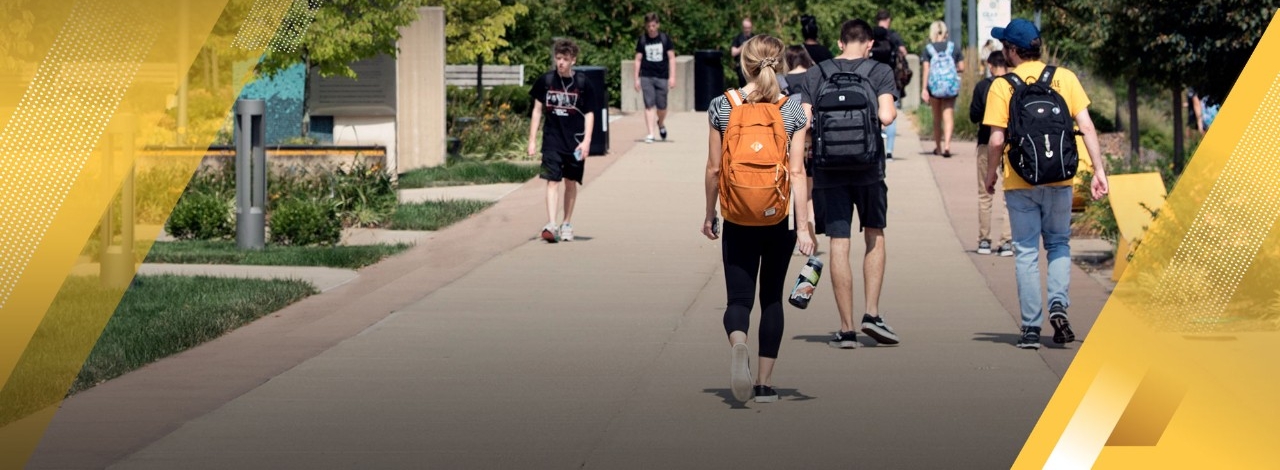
[1014, 12, 1280, 469]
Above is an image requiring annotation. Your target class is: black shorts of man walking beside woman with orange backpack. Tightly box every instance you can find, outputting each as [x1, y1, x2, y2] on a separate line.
[813, 181, 888, 238]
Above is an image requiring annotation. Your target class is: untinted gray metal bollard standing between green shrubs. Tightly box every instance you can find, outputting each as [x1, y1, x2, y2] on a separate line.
[236, 100, 266, 250]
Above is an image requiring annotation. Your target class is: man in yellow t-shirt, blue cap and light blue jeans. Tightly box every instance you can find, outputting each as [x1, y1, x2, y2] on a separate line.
[983, 19, 1107, 350]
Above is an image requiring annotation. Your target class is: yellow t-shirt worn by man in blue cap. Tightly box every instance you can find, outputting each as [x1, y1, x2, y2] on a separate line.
[982, 60, 1093, 191]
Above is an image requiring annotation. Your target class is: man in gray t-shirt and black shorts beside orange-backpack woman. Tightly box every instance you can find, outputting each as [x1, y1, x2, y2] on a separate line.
[801, 19, 899, 348]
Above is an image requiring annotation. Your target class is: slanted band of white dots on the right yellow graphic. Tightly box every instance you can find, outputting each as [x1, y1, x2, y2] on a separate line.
[1152, 76, 1280, 333]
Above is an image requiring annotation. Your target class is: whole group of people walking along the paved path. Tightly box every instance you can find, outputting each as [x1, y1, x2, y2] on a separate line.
[529, 12, 1107, 402]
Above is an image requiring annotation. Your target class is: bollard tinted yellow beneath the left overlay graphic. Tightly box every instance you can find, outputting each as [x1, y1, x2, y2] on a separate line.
[99, 114, 137, 288]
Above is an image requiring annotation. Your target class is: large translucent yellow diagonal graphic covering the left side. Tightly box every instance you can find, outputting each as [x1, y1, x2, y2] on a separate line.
[0, 0, 289, 469]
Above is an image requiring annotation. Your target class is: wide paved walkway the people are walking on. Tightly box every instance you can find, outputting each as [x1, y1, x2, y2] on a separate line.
[29, 113, 1111, 469]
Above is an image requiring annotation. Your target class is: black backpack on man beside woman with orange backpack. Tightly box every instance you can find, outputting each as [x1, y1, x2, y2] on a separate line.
[813, 59, 884, 169]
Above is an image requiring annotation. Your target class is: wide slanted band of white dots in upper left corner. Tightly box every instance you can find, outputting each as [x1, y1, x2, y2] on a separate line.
[0, 0, 157, 307]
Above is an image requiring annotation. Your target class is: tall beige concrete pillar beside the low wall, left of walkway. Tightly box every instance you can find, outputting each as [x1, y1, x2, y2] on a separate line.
[393, 6, 445, 173]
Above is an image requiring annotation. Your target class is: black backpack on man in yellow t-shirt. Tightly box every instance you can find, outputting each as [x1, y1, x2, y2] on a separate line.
[1001, 65, 1080, 186]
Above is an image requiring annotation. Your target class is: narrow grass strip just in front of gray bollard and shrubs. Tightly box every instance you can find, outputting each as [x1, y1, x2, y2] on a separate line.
[146, 241, 411, 269]
